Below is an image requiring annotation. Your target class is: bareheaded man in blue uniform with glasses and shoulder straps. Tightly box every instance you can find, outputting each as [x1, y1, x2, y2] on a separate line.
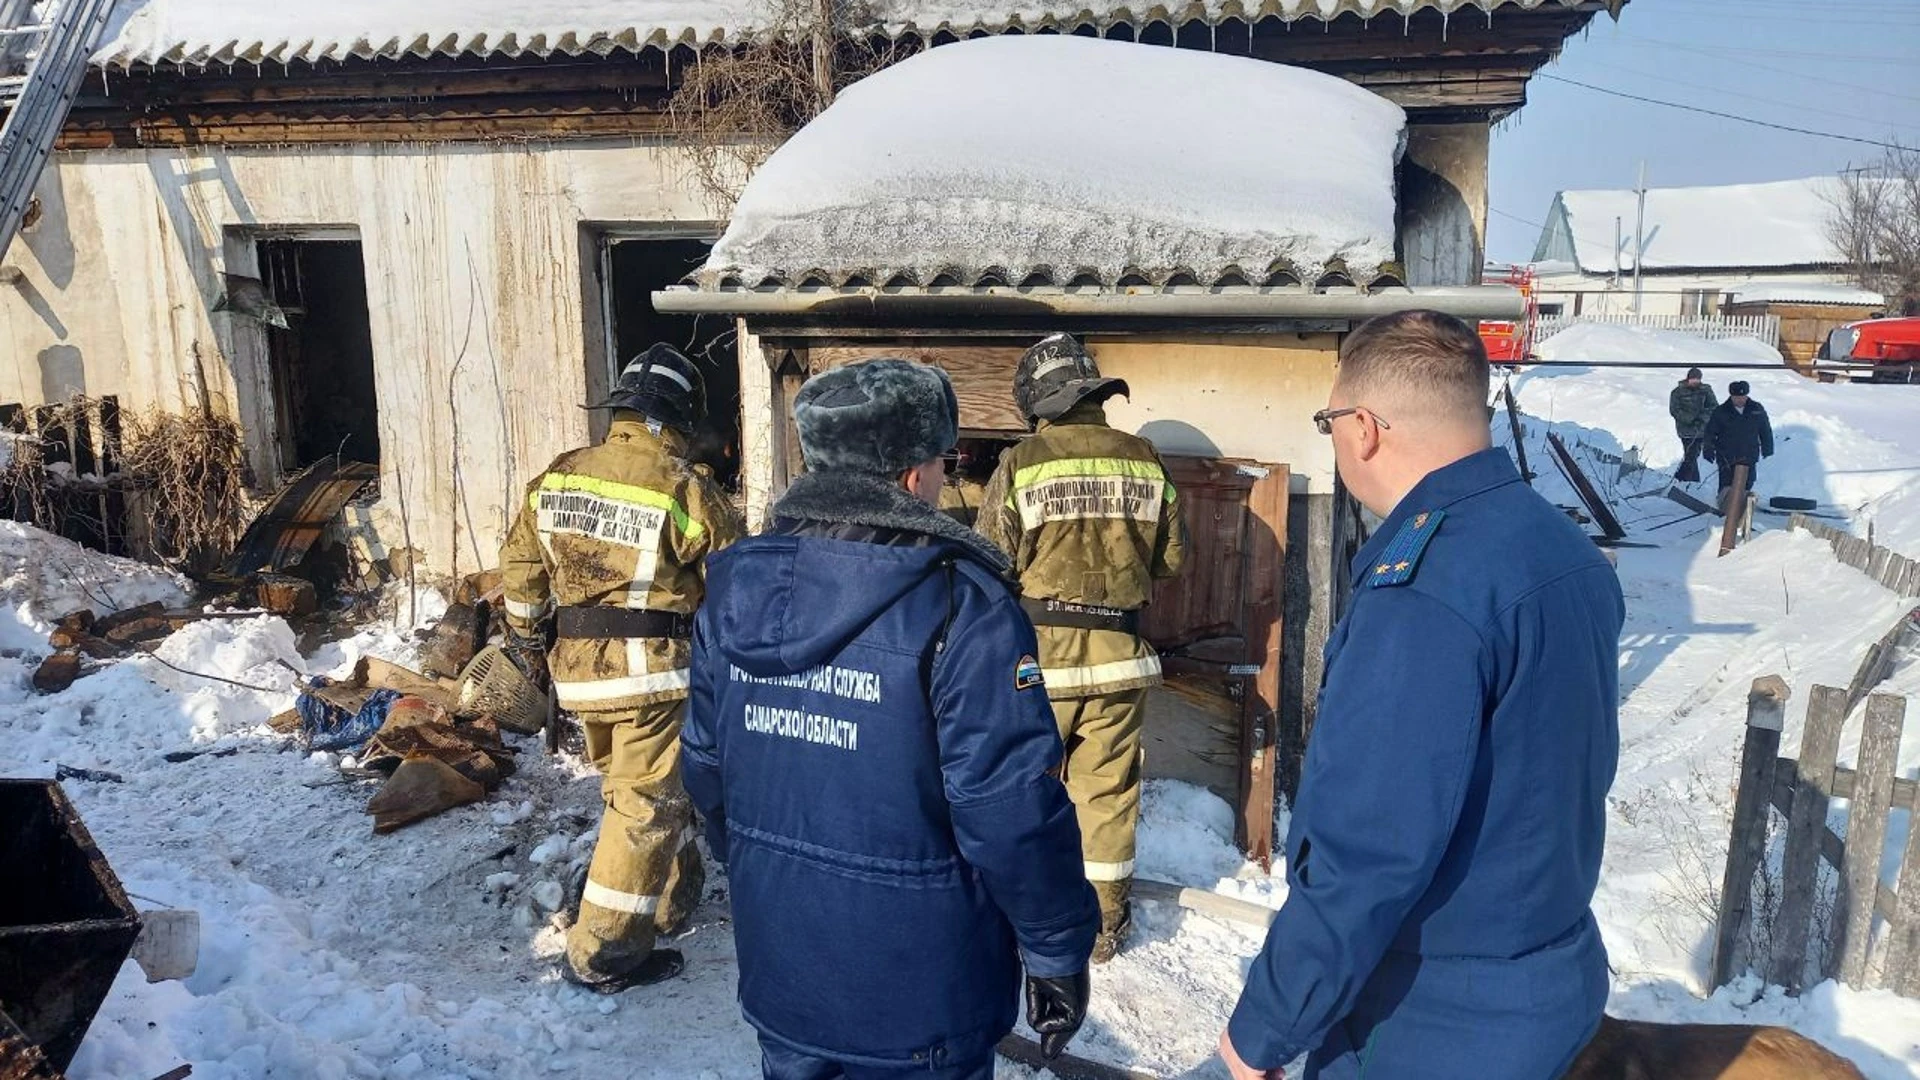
[1221, 311, 1624, 1080]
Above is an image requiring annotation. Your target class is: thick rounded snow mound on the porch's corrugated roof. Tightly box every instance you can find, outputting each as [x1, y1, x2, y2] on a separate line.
[707, 35, 1405, 282]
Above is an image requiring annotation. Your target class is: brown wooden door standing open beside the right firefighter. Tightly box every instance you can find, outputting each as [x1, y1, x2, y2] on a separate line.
[1140, 457, 1288, 865]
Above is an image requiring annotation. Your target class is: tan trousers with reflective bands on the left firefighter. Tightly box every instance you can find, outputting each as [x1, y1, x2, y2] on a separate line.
[566, 701, 707, 978]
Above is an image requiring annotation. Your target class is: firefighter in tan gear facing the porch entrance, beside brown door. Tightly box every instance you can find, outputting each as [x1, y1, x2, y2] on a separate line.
[977, 334, 1187, 963]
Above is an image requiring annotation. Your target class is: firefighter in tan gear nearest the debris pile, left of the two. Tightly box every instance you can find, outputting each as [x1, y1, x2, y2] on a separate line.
[501, 344, 745, 994]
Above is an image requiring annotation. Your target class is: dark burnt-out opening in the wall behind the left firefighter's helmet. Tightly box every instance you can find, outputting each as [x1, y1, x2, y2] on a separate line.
[605, 236, 739, 492]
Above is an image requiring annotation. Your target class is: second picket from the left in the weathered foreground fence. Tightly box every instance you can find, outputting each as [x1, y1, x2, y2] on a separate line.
[1768, 686, 1847, 990]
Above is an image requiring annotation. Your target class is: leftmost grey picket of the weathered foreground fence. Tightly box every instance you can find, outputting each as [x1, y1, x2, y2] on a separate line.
[1709, 675, 1791, 988]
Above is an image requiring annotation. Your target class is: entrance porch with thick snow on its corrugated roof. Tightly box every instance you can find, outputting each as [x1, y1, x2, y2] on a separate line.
[655, 37, 1523, 855]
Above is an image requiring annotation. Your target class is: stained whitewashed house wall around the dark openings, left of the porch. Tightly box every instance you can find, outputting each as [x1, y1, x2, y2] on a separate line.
[0, 140, 712, 573]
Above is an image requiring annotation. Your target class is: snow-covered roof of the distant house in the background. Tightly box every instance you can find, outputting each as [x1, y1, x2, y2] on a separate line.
[1534, 177, 1841, 273]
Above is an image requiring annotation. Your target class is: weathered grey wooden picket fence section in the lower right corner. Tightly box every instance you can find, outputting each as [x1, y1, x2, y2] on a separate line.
[1713, 672, 1920, 997]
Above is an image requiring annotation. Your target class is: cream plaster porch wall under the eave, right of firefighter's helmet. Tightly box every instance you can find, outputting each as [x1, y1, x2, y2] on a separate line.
[1087, 334, 1338, 494]
